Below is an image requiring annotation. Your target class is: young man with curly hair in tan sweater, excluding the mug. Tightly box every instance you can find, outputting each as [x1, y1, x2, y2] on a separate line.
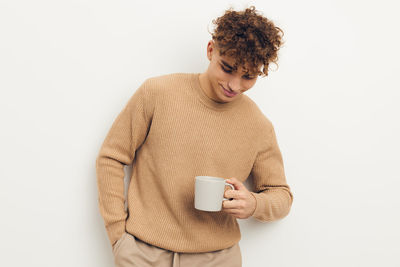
[96, 6, 293, 267]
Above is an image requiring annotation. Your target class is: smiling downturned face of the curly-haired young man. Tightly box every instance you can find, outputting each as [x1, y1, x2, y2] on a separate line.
[206, 40, 258, 102]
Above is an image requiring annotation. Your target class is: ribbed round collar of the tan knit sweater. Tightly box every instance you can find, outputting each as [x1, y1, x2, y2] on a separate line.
[191, 73, 243, 110]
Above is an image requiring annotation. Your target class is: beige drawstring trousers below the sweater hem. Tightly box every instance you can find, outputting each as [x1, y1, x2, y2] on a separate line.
[113, 232, 242, 267]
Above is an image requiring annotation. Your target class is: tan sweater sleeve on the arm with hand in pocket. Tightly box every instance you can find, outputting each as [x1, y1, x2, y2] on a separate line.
[96, 80, 150, 246]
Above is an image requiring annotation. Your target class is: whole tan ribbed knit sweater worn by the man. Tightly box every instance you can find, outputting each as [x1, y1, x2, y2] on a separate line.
[96, 73, 293, 252]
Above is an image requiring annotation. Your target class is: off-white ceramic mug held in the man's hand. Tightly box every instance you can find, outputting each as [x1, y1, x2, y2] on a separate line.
[194, 176, 235, 211]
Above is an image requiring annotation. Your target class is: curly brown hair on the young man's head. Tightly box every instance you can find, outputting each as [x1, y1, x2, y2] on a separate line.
[211, 6, 284, 77]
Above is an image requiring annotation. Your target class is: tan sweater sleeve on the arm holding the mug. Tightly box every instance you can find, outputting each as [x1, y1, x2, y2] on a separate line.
[251, 125, 293, 222]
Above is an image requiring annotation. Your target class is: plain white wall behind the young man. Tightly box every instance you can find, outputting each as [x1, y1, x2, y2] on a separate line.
[0, 0, 400, 267]
